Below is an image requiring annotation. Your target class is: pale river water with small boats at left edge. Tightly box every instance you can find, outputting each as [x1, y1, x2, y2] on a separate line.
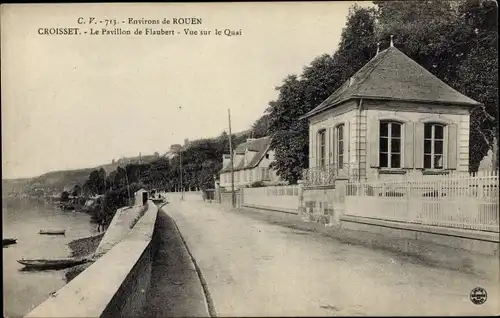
[2, 199, 97, 317]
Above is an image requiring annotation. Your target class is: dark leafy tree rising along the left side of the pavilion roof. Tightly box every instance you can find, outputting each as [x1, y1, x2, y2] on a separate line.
[267, 6, 376, 184]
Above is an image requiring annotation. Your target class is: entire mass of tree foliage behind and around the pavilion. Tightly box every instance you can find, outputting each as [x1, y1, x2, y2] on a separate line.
[267, 0, 498, 183]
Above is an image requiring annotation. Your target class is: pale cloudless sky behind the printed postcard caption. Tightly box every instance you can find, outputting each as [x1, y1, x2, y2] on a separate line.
[0, 1, 373, 178]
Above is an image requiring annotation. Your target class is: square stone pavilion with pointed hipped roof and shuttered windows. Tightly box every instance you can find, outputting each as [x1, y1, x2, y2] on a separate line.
[302, 40, 481, 184]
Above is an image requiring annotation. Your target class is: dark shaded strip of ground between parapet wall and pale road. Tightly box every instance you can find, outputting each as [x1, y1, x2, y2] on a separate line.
[142, 210, 209, 317]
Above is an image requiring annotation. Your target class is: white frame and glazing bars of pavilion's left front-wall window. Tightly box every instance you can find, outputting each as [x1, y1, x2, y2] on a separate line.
[378, 119, 404, 169]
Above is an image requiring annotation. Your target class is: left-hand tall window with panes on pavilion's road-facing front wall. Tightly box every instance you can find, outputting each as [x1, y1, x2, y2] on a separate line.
[379, 122, 401, 168]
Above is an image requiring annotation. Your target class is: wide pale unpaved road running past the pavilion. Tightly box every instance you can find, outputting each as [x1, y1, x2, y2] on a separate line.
[164, 201, 500, 316]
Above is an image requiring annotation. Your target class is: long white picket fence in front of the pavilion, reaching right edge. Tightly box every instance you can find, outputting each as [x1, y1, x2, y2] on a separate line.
[345, 171, 500, 232]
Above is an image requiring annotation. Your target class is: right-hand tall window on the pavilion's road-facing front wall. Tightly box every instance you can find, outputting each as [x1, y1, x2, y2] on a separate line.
[424, 124, 444, 169]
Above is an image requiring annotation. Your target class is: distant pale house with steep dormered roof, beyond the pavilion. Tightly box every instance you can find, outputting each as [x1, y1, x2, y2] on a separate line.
[220, 137, 280, 190]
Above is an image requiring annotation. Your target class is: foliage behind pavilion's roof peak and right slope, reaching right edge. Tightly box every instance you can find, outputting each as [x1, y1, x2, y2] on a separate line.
[374, 0, 498, 171]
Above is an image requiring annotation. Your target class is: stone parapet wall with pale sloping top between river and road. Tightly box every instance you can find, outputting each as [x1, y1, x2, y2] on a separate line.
[26, 201, 158, 317]
